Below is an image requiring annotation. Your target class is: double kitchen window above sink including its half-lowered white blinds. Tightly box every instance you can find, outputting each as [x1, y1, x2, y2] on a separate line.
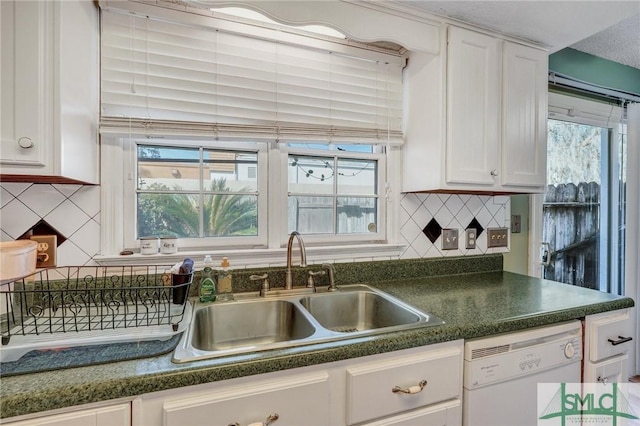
[100, 2, 404, 252]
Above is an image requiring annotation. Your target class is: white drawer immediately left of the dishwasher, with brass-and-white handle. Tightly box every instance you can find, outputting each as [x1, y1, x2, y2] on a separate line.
[347, 346, 462, 424]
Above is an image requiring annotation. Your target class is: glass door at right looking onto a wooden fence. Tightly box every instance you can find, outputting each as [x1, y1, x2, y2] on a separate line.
[534, 93, 626, 294]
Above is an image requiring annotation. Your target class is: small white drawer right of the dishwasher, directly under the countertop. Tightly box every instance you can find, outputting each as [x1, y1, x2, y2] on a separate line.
[587, 309, 633, 362]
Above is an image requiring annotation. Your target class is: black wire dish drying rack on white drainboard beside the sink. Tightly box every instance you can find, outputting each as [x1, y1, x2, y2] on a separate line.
[0, 265, 193, 362]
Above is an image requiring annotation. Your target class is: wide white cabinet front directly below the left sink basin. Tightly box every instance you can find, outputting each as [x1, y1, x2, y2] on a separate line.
[158, 372, 330, 426]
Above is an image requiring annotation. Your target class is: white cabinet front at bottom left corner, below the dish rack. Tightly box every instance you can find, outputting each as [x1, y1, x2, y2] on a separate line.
[2, 402, 131, 426]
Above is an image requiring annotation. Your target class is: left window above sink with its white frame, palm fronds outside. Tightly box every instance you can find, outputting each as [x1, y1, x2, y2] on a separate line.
[120, 140, 268, 249]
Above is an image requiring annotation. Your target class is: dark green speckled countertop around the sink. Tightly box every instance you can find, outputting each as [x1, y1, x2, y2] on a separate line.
[0, 271, 634, 418]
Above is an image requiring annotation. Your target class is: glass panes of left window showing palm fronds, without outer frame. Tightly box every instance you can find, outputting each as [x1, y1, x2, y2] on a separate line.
[136, 145, 258, 238]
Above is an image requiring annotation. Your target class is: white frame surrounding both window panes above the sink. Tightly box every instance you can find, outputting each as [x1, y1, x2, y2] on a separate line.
[114, 136, 389, 252]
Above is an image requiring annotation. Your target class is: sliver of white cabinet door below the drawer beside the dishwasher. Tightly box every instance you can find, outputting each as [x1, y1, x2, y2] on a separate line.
[363, 399, 462, 426]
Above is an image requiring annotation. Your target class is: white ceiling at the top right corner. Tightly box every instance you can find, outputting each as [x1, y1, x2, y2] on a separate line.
[393, 0, 640, 69]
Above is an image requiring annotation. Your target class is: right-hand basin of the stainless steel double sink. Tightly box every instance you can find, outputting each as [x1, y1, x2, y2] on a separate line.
[300, 291, 420, 333]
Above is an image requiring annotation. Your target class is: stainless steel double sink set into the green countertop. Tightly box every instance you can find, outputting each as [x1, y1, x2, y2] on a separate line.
[173, 285, 444, 363]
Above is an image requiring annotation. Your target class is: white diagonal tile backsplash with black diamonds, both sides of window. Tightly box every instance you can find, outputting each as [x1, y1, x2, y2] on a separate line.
[0, 182, 511, 266]
